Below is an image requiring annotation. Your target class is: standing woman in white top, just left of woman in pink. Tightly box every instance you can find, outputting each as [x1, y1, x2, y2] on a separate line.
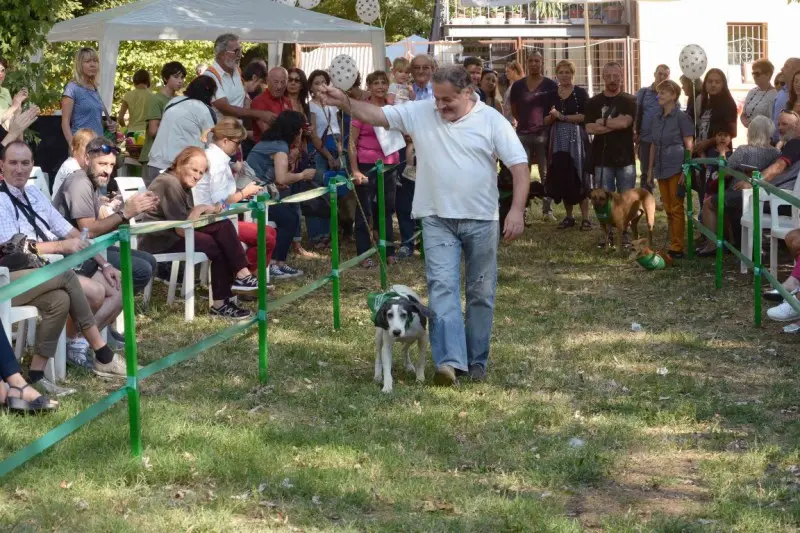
[306, 70, 342, 250]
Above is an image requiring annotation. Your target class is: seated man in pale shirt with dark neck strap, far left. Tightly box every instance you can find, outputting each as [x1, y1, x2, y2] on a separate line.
[0, 141, 130, 374]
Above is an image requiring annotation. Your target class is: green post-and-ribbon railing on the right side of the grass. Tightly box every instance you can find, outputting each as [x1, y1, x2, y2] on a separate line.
[683, 150, 800, 326]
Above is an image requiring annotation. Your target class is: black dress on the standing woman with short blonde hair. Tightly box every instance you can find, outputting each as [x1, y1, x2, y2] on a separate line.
[546, 87, 591, 205]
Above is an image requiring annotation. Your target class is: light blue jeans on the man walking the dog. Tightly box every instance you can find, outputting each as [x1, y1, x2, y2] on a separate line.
[422, 216, 500, 372]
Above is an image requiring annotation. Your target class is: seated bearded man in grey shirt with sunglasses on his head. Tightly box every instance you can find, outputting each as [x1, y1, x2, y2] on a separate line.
[53, 137, 158, 291]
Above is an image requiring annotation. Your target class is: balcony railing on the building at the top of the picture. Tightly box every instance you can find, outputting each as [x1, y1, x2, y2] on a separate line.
[445, 0, 628, 26]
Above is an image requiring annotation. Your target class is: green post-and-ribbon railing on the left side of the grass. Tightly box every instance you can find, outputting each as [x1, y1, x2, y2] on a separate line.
[0, 161, 398, 477]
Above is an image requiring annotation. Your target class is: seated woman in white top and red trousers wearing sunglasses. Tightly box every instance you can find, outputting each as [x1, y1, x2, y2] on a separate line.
[194, 118, 277, 273]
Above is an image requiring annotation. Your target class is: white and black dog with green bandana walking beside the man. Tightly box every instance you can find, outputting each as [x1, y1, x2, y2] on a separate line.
[375, 285, 431, 393]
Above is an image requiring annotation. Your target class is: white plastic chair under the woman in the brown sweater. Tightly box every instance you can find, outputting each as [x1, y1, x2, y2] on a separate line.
[116, 177, 213, 322]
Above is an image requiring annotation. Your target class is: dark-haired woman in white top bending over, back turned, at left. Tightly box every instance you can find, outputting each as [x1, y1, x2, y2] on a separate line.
[144, 76, 217, 186]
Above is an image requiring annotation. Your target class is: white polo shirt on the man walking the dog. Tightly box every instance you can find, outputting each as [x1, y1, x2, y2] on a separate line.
[382, 96, 528, 220]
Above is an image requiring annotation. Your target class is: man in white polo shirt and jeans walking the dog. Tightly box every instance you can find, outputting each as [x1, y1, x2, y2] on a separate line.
[322, 65, 530, 385]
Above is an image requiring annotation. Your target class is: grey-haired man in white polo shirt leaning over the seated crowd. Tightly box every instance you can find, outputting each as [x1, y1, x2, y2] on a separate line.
[202, 33, 275, 122]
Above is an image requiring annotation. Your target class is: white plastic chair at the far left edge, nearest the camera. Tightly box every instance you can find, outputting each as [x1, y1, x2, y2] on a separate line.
[0, 262, 67, 383]
